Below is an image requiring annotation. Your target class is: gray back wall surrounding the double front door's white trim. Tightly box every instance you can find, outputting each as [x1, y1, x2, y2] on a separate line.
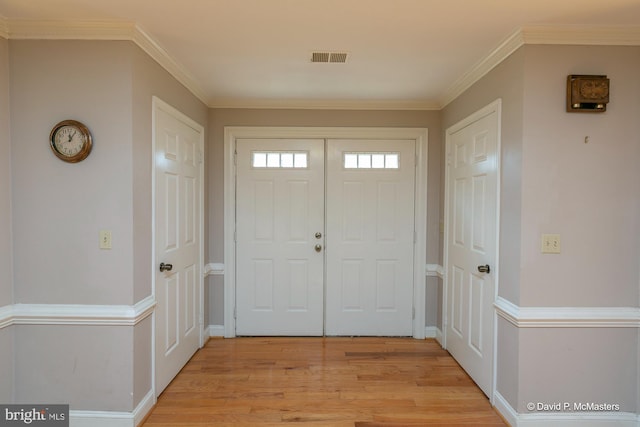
[208, 109, 442, 326]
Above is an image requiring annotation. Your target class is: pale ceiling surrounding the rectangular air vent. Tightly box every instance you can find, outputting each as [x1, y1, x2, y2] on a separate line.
[0, 0, 640, 109]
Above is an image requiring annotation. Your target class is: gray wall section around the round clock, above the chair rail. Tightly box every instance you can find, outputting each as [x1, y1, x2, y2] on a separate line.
[10, 40, 135, 304]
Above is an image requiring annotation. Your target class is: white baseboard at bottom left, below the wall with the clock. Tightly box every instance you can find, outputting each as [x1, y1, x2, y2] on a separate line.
[69, 390, 155, 427]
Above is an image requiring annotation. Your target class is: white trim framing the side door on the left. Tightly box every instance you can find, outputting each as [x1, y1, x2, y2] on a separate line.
[151, 96, 208, 403]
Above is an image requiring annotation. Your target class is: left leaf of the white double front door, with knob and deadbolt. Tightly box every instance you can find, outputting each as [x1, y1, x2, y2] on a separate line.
[236, 139, 324, 335]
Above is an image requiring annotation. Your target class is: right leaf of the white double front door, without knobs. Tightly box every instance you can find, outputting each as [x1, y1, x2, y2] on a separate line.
[326, 140, 415, 336]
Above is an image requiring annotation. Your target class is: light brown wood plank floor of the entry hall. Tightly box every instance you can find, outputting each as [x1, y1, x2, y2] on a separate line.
[143, 338, 506, 427]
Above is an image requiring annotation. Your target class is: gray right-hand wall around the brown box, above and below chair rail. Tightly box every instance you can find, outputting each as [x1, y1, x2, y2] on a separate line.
[443, 45, 640, 413]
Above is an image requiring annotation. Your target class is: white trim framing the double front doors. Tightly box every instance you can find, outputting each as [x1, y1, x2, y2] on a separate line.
[224, 126, 428, 339]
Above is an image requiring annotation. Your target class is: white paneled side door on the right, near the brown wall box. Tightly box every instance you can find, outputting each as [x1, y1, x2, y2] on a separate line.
[445, 104, 500, 398]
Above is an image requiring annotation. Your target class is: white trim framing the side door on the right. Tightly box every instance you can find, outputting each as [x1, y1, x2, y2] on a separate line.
[442, 99, 502, 404]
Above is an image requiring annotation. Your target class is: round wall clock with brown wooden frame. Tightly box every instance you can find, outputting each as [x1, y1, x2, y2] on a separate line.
[49, 120, 93, 163]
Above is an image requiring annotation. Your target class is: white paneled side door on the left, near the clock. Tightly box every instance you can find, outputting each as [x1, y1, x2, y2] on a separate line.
[154, 100, 203, 395]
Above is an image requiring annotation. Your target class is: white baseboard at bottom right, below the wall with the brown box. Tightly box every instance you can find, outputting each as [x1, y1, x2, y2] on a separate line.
[493, 391, 640, 427]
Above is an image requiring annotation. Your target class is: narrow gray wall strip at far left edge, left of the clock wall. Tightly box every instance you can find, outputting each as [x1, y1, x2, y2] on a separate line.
[0, 37, 13, 403]
